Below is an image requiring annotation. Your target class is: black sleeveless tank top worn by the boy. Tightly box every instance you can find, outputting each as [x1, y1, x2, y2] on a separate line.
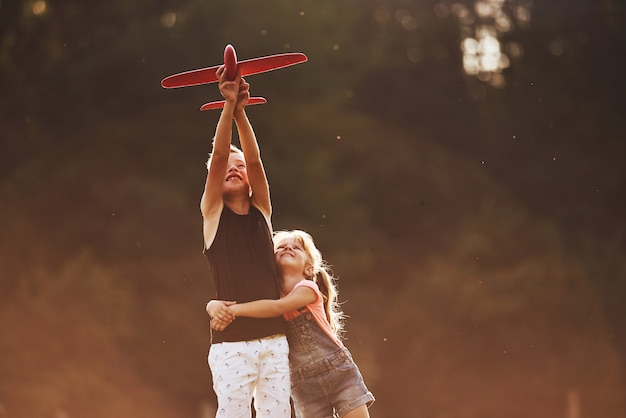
[204, 205, 285, 343]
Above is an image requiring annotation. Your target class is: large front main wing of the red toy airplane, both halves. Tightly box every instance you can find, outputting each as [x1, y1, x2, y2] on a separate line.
[161, 52, 307, 89]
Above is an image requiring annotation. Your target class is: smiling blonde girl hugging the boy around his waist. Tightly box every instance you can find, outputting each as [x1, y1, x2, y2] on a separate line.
[207, 230, 374, 418]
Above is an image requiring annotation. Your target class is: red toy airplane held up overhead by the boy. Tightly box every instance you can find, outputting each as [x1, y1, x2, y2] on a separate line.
[161, 44, 307, 110]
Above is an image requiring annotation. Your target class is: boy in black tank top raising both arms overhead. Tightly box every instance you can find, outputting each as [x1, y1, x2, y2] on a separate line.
[200, 66, 291, 418]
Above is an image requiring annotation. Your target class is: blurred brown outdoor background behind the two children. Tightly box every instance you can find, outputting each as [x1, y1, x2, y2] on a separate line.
[0, 0, 626, 418]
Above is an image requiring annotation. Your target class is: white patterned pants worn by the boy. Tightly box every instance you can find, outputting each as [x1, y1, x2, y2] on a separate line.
[209, 335, 291, 418]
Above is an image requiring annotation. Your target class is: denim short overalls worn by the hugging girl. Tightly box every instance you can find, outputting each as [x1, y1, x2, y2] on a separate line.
[286, 308, 374, 418]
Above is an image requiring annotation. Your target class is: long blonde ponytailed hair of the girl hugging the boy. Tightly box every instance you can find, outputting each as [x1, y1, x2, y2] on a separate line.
[274, 229, 345, 337]
